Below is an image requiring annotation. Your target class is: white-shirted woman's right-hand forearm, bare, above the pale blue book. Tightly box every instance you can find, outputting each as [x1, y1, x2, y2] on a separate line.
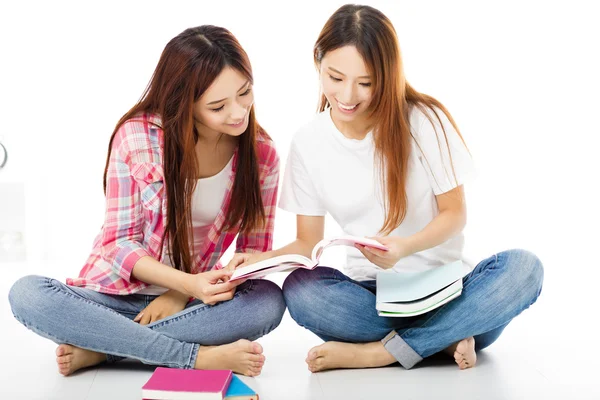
[406, 211, 467, 254]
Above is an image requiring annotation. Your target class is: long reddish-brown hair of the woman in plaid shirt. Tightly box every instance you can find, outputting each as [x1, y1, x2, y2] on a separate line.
[104, 25, 266, 272]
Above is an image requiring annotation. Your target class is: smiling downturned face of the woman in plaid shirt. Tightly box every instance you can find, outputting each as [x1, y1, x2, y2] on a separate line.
[194, 67, 254, 137]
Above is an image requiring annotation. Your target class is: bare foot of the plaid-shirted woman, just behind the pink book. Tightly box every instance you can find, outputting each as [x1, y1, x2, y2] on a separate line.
[194, 339, 265, 376]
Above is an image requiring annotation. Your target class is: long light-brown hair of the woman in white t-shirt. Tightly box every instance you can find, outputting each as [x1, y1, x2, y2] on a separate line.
[313, 4, 462, 234]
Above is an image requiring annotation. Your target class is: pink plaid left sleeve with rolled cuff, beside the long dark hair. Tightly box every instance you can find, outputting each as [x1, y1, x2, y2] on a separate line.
[100, 122, 150, 282]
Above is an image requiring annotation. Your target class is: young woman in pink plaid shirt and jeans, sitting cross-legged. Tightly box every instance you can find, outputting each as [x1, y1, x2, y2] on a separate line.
[9, 26, 285, 376]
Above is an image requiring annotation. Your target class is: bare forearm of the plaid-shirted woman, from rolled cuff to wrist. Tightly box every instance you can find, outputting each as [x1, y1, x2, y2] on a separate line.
[131, 256, 189, 297]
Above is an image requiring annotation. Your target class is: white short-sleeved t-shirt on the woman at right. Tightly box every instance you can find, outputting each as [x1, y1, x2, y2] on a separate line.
[279, 107, 475, 281]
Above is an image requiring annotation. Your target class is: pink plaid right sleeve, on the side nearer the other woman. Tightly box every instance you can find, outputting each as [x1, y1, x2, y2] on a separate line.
[235, 141, 279, 253]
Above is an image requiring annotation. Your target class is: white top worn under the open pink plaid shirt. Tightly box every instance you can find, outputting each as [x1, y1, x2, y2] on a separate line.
[137, 157, 233, 295]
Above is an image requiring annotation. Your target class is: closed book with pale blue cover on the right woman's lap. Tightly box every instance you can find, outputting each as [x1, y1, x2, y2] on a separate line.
[375, 260, 471, 317]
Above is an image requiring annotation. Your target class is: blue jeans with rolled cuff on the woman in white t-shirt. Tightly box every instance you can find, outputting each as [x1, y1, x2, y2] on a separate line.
[283, 250, 544, 369]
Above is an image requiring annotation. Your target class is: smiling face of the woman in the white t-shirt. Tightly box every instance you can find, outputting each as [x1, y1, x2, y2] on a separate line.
[319, 46, 372, 122]
